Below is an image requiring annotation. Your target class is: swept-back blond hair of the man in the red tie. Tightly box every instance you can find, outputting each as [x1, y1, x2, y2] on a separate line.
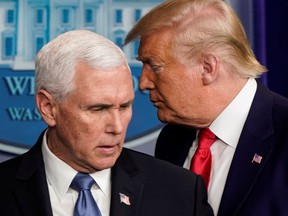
[124, 0, 267, 77]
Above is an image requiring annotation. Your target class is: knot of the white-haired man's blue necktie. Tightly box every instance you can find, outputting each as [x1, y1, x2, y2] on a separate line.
[71, 173, 95, 192]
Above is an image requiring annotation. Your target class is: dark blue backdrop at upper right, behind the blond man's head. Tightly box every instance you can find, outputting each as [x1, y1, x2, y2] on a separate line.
[260, 0, 288, 97]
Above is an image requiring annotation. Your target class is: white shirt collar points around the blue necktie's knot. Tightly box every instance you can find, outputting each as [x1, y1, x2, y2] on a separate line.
[42, 131, 111, 200]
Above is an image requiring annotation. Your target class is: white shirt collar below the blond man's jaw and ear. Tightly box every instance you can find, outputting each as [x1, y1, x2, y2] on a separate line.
[209, 78, 257, 148]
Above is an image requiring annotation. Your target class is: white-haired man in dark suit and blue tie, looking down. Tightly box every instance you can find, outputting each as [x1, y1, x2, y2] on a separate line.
[0, 30, 213, 216]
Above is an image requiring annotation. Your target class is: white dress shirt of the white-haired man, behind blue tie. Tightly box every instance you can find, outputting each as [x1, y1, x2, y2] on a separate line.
[42, 132, 111, 216]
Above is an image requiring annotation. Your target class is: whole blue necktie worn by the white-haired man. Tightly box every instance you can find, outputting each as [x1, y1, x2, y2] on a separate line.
[70, 173, 101, 216]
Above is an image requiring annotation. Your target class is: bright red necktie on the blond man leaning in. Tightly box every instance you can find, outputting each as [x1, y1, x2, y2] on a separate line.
[190, 128, 216, 189]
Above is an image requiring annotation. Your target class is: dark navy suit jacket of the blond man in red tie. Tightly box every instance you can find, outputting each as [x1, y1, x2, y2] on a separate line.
[155, 83, 288, 216]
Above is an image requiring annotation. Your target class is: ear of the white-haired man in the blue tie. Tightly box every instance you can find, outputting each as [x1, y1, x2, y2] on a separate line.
[36, 89, 56, 127]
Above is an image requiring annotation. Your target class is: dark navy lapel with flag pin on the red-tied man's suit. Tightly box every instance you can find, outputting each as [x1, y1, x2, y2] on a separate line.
[218, 83, 274, 216]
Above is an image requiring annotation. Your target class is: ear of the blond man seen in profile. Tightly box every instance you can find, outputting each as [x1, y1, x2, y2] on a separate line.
[202, 54, 219, 85]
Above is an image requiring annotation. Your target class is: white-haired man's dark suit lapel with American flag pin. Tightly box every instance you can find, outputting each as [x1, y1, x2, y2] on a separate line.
[110, 149, 145, 216]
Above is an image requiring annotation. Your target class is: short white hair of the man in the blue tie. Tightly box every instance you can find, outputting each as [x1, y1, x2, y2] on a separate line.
[35, 30, 129, 102]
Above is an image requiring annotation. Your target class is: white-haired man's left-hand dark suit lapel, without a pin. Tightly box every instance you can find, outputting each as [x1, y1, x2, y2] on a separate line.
[14, 135, 52, 216]
